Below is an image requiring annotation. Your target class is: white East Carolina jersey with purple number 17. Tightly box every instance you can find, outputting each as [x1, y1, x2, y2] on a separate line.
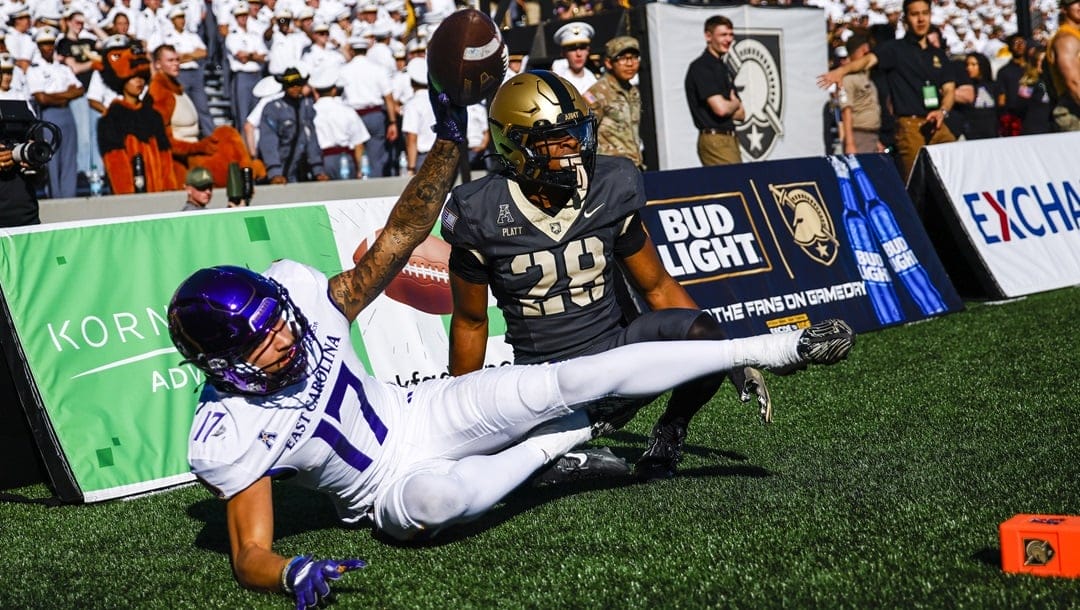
[188, 260, 405, 520]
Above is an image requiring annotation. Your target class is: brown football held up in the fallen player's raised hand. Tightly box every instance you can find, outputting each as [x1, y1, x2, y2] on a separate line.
[428, 9, 508, 106]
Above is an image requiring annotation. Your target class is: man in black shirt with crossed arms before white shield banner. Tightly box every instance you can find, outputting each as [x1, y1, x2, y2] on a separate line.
[684, 15, 746, 165]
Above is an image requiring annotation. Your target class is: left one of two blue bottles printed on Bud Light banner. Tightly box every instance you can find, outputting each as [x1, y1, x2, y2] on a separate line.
[827, 157, 904, 324]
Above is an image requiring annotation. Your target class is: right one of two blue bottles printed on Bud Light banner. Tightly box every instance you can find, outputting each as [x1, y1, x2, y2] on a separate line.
[847, 154, 945, 315]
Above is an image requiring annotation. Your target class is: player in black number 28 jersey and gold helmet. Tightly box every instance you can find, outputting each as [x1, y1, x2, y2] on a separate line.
[443, 70, 772, 478]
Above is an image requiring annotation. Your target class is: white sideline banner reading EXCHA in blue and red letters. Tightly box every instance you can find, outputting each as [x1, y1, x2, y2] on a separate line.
[927, 133, 1080, 297]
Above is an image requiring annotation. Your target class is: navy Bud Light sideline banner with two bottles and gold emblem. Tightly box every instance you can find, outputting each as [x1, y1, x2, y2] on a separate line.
[642, 154, 963, 337]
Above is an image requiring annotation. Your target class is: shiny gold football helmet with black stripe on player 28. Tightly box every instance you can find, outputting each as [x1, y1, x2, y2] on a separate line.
[488, 70, 596, 190]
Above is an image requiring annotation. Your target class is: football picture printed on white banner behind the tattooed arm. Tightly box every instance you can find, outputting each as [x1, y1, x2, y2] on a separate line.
[352, 229, 454, 315]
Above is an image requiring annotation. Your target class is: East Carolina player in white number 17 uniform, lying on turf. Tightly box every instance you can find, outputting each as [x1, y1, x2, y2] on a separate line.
[168, 82, 854, 608]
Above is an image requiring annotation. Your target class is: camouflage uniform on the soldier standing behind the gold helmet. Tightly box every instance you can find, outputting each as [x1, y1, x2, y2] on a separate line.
[584, 73, 645, 167]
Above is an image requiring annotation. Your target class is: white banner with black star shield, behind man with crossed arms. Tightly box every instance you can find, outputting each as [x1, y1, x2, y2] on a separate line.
[646, 2, 828, 170]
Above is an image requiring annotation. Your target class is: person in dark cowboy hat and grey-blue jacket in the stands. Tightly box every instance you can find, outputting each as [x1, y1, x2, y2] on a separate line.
[259, 67, 329, 185]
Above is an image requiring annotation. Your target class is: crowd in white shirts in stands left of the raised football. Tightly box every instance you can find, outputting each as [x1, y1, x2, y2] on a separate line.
[0, 0, 483, 198]
